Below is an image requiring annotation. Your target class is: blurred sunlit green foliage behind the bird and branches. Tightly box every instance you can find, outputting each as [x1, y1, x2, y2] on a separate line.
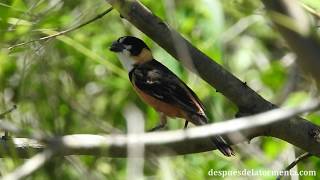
[0, 0, 320, 180]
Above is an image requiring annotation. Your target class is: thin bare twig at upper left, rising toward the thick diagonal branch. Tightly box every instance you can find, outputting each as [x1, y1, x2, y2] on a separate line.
[8, 7, 113, 50]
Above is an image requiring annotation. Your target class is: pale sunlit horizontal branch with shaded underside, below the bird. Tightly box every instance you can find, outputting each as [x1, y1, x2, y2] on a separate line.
[0, 101, 320, 158]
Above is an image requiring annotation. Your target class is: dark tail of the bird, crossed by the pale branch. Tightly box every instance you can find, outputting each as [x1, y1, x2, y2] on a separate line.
[189, 114, 235, 157]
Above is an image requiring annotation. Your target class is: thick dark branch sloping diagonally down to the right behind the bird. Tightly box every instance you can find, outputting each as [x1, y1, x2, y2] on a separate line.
[107, 0, 320, 154]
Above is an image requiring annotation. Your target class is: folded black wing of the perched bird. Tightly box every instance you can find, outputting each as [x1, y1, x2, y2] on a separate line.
[129, 60, 204, 114]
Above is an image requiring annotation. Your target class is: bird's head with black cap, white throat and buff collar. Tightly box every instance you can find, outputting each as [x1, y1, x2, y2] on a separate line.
[110, 36, 153, 71]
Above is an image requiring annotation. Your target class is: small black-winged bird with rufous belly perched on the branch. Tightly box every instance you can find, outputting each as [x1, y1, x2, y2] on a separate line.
[110, 36, 234, 156]
